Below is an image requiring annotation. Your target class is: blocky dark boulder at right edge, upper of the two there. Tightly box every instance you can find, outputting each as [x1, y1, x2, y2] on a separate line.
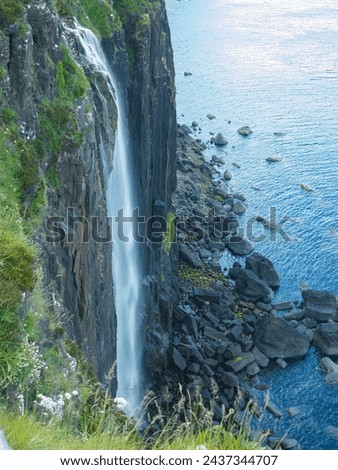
[302, 289, 338, 322]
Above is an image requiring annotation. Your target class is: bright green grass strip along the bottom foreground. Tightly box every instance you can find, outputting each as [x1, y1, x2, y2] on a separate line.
[0, 384, 262, 450]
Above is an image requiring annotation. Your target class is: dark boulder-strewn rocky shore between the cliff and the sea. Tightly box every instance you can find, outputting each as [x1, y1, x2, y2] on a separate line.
[155, 123, 338, 448]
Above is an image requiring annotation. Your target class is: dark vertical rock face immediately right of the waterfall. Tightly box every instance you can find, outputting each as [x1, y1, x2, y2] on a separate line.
[126, 1, 177, 390]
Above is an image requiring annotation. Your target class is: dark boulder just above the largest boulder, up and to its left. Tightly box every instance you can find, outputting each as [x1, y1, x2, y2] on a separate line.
[230, 268, 274, 302]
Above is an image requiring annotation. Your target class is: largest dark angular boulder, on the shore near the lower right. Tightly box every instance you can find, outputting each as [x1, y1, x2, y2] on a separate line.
[253, 315, 310, 359]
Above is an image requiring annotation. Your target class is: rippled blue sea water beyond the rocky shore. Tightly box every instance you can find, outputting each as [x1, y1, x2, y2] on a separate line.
[166, 0, 338, 449]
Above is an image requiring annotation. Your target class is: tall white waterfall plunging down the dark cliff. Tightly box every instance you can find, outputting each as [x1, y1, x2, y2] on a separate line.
[67, 23, 143, 412]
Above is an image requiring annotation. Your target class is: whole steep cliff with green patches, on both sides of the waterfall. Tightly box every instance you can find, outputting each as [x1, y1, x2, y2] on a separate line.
[0, 0, 176, 392]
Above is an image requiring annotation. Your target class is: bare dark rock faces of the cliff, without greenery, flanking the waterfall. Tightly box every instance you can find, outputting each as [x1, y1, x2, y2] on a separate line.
[0, 1, 176, 392]
